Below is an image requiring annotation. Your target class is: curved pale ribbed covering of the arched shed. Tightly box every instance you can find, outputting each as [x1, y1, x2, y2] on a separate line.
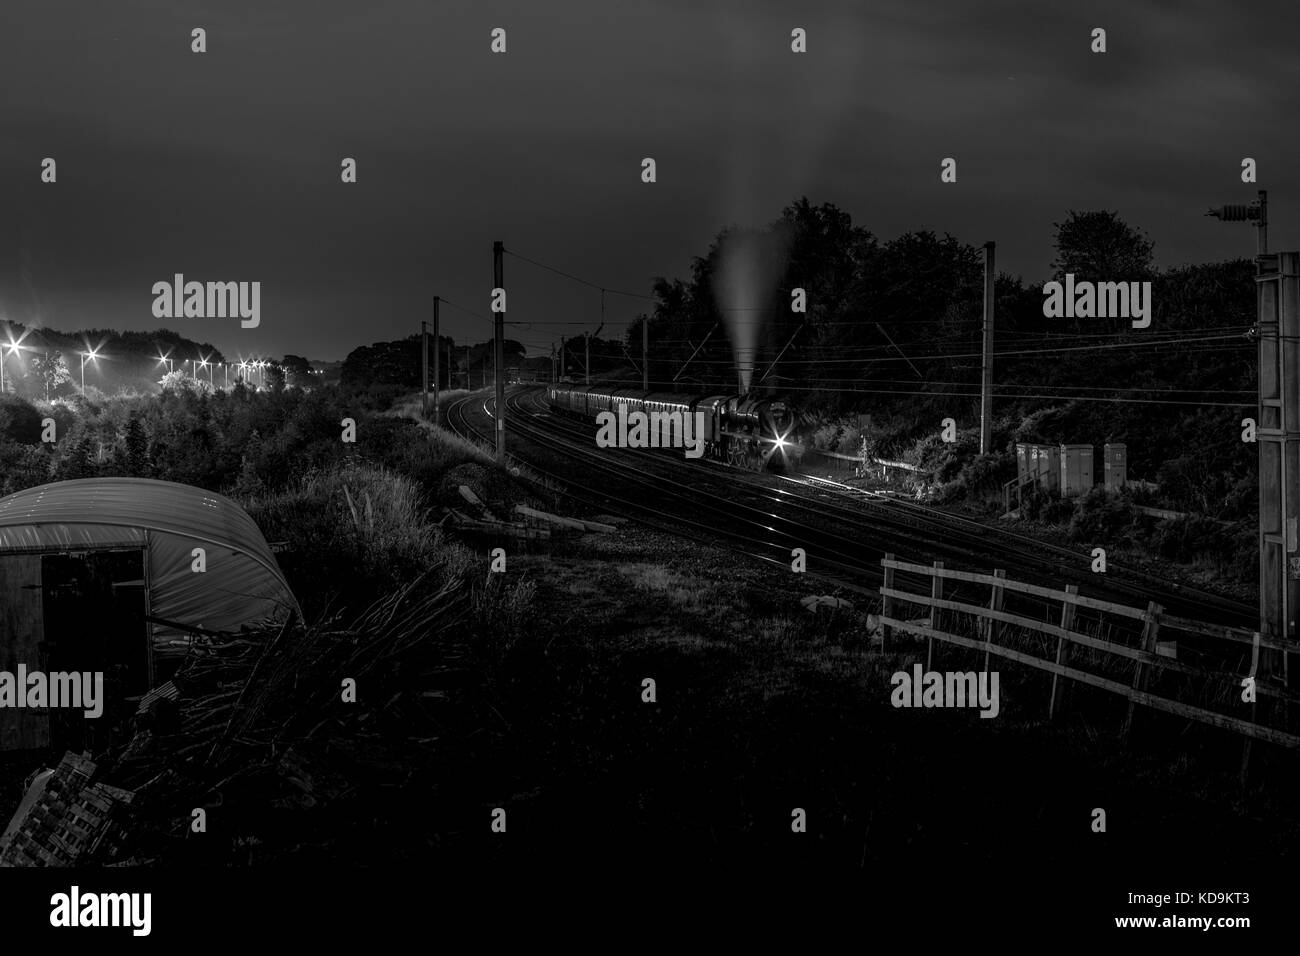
[0, 477, 298, 637]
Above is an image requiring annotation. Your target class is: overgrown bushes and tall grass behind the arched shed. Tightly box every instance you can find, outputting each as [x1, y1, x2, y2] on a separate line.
[0, 388, 538, 630]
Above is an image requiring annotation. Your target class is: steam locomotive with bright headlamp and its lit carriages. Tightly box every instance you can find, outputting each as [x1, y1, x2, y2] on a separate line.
[546, 382, 803, 471]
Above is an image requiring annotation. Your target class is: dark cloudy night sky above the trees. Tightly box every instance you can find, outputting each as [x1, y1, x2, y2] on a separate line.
[0, 0, 1300, 359]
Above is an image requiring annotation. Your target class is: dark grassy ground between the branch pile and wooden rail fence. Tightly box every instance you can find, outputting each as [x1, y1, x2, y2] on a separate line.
[441, 531, 1297, 871]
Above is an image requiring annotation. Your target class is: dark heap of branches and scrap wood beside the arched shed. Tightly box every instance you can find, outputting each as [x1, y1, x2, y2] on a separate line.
[0, 566, 501, 866]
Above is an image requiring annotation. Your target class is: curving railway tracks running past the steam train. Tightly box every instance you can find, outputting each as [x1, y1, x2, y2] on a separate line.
[449, 392, 1256, 627]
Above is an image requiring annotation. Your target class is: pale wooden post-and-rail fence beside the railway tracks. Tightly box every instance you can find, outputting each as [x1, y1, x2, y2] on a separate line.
[880, 554, 1300, 748]
